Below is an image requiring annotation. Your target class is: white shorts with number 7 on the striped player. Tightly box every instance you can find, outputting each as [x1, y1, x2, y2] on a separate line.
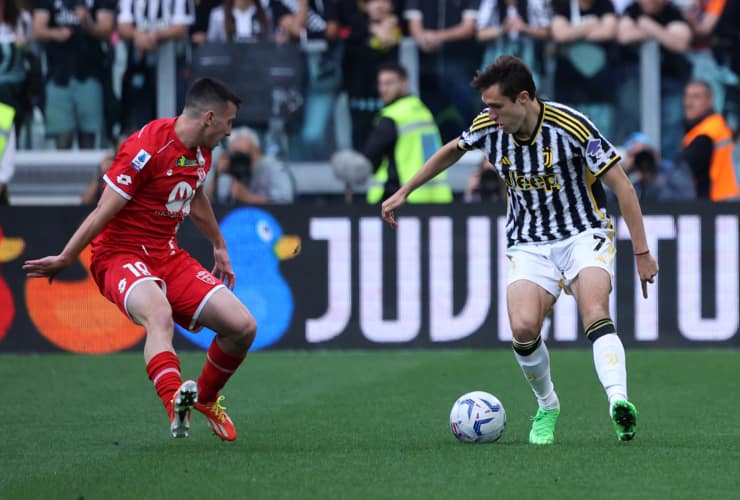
[506, 229, 617, 298]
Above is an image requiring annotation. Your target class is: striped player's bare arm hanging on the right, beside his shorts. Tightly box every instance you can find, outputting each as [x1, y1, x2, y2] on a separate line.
[600, 164, 658, 298]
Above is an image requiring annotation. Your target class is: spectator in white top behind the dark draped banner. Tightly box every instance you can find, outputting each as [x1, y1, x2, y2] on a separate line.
[206, 0, 272, 42]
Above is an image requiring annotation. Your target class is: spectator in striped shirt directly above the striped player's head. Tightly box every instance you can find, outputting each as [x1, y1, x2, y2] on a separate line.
[477, 0, 552, 88]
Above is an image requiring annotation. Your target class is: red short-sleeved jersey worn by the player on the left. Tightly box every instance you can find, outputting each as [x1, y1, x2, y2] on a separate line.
[92, 118, 211, 253]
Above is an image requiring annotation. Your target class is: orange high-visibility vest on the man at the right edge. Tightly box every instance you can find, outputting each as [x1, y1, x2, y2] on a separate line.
[682, 113, 740, 201]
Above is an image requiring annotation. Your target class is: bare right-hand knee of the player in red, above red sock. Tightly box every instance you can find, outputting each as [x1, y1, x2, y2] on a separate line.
[198, 287, 257, 336]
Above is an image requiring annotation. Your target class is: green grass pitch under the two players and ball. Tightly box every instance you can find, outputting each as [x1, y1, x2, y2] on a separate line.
[0, 349, 740, 499]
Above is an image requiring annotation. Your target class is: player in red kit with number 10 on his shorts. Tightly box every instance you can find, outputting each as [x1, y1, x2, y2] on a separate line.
[23, 78, 257, 441]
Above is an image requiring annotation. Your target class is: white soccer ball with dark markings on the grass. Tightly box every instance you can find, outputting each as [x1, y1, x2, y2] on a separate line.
[450, 391, 506, 443]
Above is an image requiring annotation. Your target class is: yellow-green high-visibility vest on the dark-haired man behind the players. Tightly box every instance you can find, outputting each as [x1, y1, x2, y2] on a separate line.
[367, 95, 452, 203]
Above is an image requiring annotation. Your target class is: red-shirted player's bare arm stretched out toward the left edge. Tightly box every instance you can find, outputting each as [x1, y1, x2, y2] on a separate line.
[23, 189, 128, 283]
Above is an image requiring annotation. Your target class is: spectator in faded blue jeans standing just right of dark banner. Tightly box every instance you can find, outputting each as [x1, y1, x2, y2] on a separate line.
[273, 0, 342, 160]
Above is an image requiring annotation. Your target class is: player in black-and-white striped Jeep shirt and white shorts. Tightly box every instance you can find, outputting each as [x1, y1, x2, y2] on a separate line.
[381, 56, 658, 445]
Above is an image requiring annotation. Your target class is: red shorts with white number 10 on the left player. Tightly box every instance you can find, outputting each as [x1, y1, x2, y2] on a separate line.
[90, 249, 224, 331]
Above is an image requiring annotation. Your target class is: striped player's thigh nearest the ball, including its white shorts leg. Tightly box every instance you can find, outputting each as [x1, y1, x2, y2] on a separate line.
[506, 245, 561, 341]
